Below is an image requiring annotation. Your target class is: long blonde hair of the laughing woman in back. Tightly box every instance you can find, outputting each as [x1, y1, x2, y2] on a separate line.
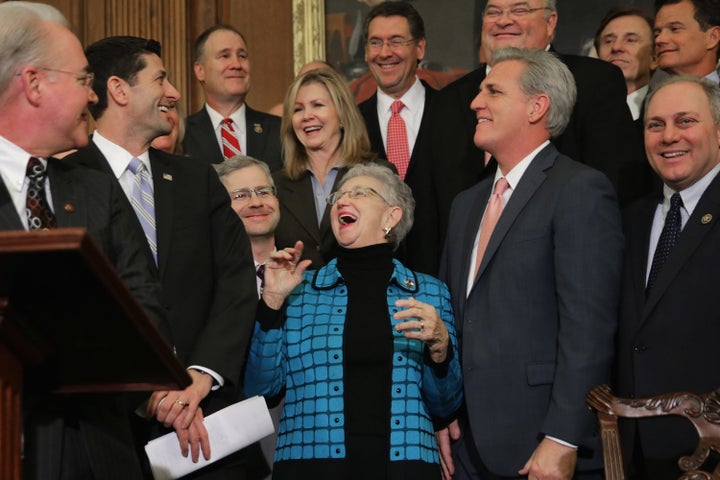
[280, 69, 375, 180]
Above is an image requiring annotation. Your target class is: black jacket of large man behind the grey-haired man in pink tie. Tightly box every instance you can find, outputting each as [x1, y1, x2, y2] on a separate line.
[431, 55, 647, 246]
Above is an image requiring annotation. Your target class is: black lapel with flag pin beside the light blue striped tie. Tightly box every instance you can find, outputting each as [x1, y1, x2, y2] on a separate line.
[150, 148, 176, 278]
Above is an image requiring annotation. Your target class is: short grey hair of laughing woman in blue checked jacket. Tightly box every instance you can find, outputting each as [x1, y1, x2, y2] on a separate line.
[337, 162, 415, 249]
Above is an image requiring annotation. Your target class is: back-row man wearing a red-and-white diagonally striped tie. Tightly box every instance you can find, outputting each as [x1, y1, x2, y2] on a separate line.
[183, 25, 282, 172]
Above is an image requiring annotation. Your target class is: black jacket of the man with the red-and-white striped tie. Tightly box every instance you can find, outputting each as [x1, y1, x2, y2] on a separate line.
[182, 105, 282, 172]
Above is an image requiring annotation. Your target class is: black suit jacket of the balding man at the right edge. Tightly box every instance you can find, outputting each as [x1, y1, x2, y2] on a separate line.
[616, 175, 720, 459]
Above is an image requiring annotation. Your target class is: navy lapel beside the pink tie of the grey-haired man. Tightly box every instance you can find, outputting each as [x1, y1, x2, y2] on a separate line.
[478, 144, 558, 278]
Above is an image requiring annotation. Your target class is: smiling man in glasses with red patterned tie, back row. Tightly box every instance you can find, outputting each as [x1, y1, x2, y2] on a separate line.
[359, 2, 441, 275]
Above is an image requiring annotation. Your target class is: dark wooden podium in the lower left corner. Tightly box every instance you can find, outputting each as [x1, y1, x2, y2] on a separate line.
[0, 229, 190, 480]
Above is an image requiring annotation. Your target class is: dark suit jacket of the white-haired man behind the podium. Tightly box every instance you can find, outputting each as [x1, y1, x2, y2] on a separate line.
[0, 158, 170, 479]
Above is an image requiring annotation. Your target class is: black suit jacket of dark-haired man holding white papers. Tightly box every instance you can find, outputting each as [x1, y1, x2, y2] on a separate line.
[65, 142, 257, 386]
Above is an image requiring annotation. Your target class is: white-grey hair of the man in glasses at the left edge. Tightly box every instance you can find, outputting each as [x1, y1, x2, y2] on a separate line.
[0, 1, 68, 95]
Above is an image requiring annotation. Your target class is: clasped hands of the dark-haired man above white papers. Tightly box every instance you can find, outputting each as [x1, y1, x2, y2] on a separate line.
[147, 369, 213, 463]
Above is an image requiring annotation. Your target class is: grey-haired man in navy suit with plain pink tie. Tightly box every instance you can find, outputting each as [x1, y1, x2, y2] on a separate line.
[439, 49, 623, 479]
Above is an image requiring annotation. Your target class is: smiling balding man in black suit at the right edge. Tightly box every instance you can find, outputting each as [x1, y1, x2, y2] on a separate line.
[616, 76, 720, 480]
